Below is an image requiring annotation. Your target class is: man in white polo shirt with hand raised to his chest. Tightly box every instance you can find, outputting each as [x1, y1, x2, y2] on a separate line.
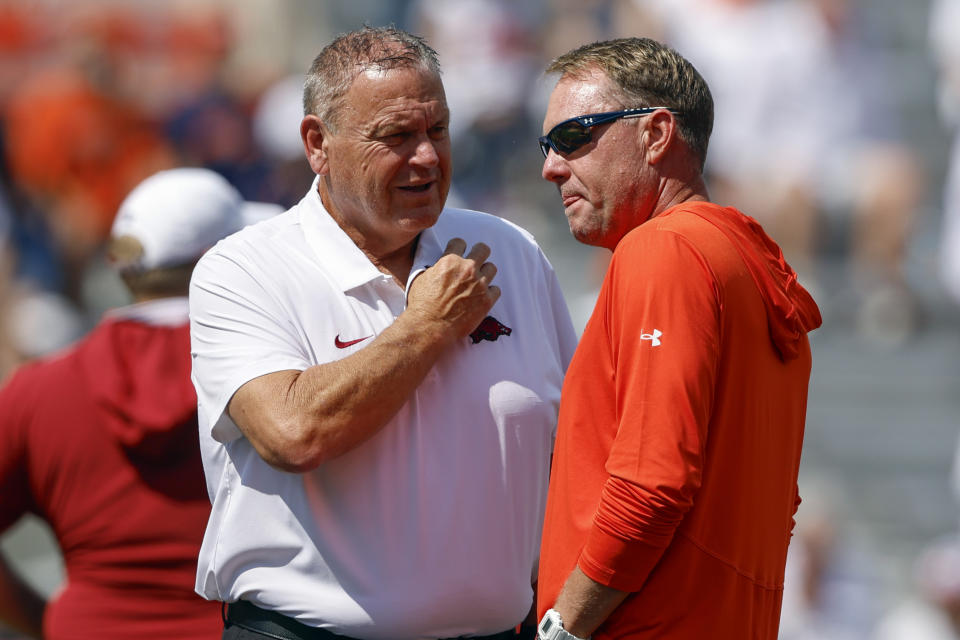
[190, 28, 575, 640]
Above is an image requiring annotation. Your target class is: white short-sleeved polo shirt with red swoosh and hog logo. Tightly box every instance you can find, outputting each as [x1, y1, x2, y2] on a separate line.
[190, 183, 576, 640]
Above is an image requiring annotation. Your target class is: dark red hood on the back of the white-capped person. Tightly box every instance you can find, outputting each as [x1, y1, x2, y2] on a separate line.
[77, 302, 197, 460]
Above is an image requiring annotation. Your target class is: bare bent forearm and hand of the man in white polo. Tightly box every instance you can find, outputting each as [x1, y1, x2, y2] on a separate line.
[227, 238, 500, 473]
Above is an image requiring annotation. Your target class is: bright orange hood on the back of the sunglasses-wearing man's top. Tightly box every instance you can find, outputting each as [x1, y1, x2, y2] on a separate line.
[677, 202, 823, 360]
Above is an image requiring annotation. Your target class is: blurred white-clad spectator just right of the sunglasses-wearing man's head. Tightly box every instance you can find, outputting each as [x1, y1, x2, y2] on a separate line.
[636, 0, 828, 268]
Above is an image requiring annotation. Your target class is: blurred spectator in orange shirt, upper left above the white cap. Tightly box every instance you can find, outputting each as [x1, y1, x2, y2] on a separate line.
[3, 65, 172, 297]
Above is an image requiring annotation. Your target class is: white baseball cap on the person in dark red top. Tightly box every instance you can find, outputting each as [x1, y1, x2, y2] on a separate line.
[110, 168, 262, 271]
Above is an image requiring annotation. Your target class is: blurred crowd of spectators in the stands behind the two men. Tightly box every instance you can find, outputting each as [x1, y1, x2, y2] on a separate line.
[0, 0, 960, 640]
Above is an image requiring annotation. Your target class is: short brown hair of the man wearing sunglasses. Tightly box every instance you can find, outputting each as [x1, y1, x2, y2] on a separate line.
[547, 38, 713, 171]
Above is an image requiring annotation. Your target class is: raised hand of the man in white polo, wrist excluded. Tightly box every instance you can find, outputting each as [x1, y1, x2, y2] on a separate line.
[407, 238, 500, 342]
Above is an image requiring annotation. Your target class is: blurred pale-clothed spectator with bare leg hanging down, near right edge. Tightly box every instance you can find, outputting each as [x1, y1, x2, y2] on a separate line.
[809, 0, 928, 344]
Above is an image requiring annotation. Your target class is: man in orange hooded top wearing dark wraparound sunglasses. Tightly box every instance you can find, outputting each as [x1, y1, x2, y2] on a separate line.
[537, 38, 821, 640]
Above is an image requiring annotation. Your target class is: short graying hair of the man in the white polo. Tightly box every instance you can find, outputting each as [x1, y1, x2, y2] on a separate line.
[303, 26, 440, 127]
